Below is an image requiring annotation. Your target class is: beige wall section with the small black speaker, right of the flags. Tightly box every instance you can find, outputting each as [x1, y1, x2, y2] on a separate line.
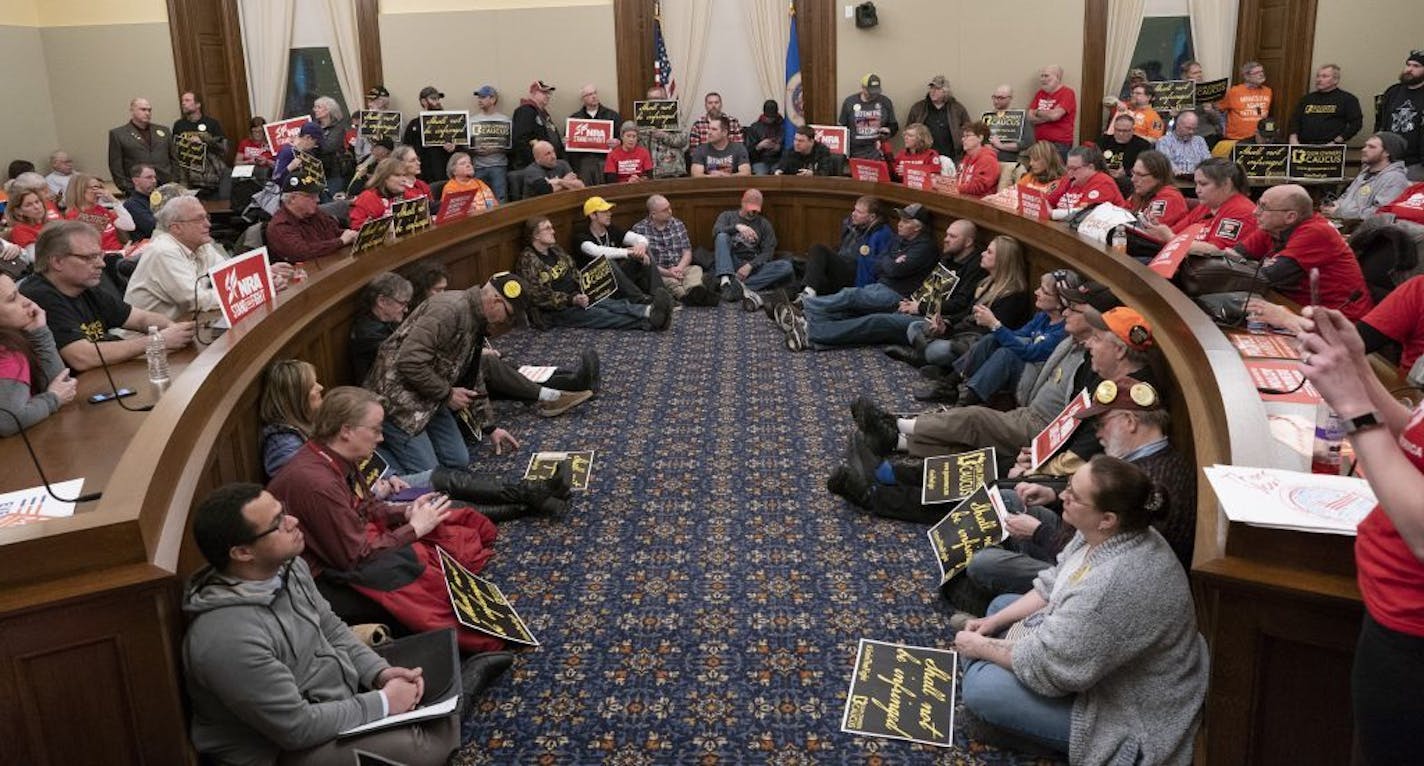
[836, 0, 1087, 145]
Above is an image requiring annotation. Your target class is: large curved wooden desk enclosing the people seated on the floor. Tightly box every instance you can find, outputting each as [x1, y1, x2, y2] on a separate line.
[0, 177, 1360, 763]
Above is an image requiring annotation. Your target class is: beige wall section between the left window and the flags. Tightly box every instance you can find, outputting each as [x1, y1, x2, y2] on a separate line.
[380, 0, 618, 120]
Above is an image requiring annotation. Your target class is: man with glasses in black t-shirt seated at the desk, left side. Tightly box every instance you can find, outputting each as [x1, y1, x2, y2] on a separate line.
[20, 221, 194, 372]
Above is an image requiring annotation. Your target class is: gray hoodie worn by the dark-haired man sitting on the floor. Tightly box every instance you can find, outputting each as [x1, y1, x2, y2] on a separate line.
[182, 558, 389, 765]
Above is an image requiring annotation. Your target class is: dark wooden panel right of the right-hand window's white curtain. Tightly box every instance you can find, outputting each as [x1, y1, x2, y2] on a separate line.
[1232, 0, 1316, 133]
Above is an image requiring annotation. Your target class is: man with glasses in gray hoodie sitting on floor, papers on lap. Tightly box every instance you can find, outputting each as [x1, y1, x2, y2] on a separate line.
[184, 484, 514, 763]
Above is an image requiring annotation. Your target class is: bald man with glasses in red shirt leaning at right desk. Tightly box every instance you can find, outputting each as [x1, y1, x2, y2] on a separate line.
[1218, 184, 1374, 320]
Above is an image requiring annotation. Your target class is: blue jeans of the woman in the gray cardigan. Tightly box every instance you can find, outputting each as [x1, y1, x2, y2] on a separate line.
[960, 594, 1074, 753]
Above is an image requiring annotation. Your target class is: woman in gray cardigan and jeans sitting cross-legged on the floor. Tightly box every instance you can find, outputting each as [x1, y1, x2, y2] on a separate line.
[954, 456, 1208, 765]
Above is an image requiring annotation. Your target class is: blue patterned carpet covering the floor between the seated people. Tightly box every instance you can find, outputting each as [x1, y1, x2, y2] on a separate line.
[454, 300, 1065, 765]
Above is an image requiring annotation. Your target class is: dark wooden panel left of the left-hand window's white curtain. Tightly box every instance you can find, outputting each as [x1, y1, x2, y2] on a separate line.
[168, 0, 252, 162]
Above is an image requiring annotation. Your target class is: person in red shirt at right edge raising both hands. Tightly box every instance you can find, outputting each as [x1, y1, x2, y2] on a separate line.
[1297, 306, 1424, 763]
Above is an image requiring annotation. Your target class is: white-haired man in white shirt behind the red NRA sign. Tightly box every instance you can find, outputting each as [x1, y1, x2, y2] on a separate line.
[124, 196, 226, 319]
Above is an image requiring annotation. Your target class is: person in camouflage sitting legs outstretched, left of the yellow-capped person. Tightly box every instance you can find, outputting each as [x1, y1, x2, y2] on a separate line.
[517, 215, 672, 330]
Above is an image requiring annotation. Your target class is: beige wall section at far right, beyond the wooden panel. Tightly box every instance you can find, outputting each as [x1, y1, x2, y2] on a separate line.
[1310, 0, 1424, 144]
